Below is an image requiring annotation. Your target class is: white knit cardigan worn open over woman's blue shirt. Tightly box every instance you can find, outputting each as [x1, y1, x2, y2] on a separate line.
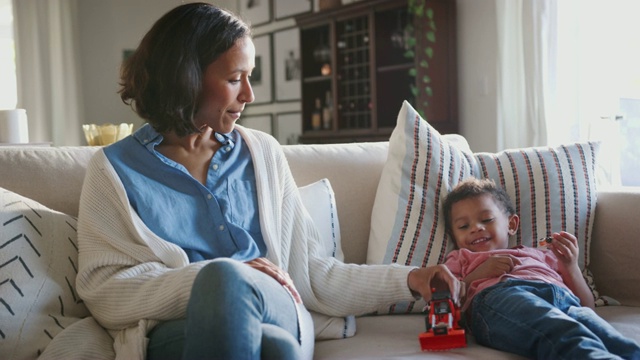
[76, 126, 413, 359]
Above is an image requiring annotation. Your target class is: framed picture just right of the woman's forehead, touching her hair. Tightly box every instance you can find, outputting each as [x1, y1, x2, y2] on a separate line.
[249, 34, 273, 106]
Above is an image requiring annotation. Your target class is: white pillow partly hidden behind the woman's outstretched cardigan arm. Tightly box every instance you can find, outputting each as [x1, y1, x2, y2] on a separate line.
[298, 179, 356, 340]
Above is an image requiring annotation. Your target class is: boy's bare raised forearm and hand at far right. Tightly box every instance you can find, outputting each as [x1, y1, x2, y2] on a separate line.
[549, 231, 595, 309]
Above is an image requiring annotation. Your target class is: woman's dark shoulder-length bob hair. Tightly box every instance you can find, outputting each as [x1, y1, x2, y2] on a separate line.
[118, 3, 251, 136]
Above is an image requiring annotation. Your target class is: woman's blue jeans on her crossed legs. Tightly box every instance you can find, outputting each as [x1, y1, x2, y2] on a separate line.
[147, 259, 301, 360]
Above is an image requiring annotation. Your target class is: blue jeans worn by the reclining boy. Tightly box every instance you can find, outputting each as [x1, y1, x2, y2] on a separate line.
[470, 280, 640, 359]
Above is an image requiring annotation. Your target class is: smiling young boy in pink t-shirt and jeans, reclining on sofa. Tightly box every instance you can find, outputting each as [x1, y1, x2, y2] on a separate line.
[443, 179, 640, 359]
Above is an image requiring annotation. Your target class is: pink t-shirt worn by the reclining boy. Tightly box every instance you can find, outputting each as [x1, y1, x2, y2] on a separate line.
[444, 246, 568, 311]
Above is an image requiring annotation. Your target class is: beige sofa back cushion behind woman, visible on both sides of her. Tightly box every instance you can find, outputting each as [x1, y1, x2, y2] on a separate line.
[0, 142, 388, 263]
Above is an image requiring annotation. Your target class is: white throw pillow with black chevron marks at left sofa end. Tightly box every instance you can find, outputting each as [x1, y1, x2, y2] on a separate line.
[0, 188, 89, 359]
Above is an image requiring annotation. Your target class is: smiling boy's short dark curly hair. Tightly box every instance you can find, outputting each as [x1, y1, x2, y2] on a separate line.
[442, 178, 516, 237]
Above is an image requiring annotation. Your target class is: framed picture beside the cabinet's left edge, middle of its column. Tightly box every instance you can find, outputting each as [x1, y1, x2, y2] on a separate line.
[273, 28, 302, 101]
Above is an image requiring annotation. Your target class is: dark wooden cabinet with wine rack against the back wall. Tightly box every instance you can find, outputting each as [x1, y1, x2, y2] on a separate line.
[296, 0, 458, 143]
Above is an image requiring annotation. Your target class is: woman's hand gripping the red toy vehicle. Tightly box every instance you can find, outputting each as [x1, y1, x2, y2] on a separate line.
[407, 264, 465, 306]
